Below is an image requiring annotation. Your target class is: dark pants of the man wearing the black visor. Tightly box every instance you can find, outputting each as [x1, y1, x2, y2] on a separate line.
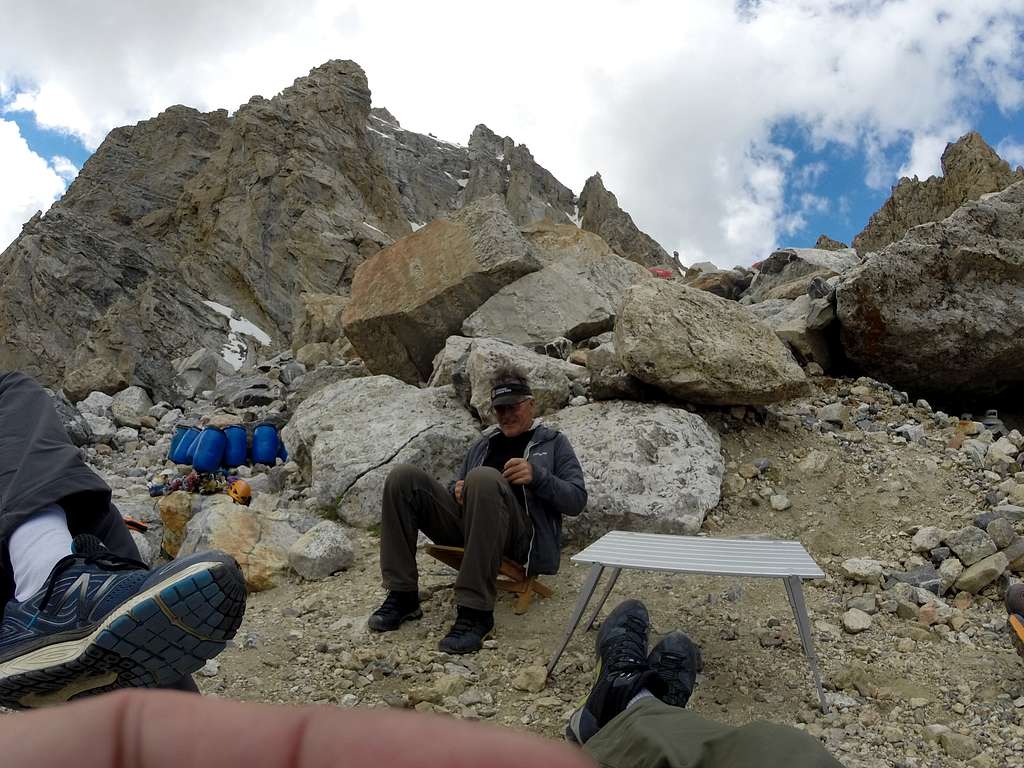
[381, 464, 534, 610]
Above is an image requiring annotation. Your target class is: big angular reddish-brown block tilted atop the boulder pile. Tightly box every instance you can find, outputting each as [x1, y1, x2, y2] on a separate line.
[343, 196, 541, 383]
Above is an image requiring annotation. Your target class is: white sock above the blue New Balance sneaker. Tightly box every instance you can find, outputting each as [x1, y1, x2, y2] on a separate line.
[7, 504, 71, 602]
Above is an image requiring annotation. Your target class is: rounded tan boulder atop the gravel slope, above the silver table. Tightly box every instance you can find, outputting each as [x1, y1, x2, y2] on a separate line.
[614, 280, 807, 406]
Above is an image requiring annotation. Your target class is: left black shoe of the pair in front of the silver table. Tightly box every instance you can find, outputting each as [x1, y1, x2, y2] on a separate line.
[565, 600, 665, 744]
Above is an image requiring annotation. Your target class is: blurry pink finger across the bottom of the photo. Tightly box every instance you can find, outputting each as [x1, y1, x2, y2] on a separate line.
[0, 691, 592, 768]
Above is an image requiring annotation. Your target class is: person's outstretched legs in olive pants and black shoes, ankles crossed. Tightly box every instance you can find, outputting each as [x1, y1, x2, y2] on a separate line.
[565, 600, 843, 768]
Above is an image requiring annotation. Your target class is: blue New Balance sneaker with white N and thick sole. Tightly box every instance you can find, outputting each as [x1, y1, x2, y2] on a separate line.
[0, 536, 246, 709]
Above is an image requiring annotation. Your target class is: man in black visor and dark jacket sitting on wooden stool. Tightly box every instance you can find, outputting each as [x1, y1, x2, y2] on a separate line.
[368, 368, 587, 653]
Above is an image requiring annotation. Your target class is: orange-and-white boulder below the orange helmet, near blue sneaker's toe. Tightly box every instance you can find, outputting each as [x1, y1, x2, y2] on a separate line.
[178, 494, 299, 592]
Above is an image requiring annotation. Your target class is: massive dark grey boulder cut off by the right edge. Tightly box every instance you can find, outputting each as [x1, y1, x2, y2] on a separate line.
[837, 182, 1024, 397]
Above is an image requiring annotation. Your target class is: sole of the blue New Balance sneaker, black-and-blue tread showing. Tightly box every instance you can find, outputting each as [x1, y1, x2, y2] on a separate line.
[0, 561, 246, 710]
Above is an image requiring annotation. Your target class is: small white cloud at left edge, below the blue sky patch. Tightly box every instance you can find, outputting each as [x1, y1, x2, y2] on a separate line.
[0, 120, 65, 251]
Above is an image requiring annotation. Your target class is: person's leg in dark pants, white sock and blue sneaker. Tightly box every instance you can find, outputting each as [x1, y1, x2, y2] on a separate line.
[0, 372, 245, 709]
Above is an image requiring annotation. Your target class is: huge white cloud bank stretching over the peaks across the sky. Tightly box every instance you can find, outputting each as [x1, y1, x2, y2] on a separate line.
[0, 0, 1024, 263]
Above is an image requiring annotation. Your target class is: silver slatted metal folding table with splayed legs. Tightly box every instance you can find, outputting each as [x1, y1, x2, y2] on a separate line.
[548, 530, 828, 713]
